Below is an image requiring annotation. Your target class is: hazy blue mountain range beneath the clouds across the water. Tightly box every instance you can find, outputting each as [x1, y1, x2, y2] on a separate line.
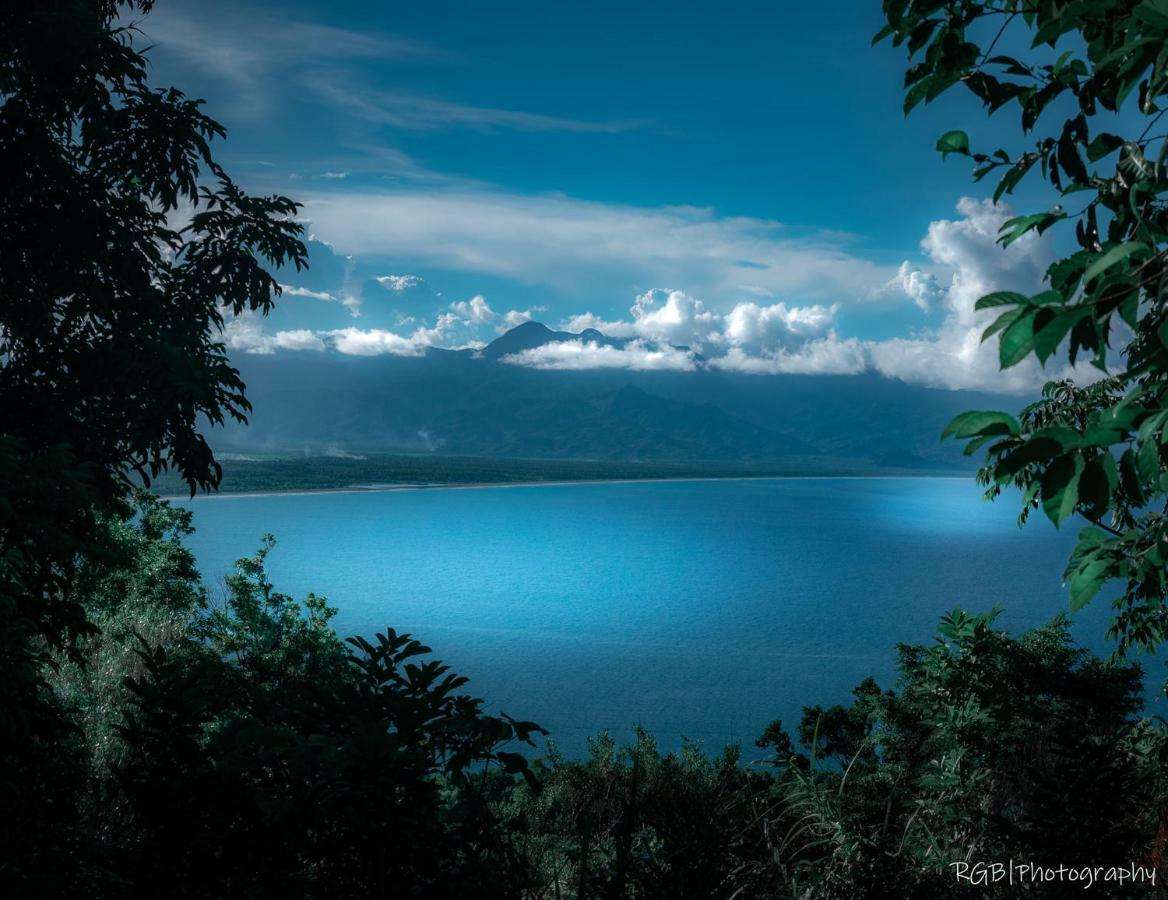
[215, 322, 1018, 470]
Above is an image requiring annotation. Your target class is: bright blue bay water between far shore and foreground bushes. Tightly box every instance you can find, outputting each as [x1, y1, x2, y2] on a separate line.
[177, 479, 1125, 758]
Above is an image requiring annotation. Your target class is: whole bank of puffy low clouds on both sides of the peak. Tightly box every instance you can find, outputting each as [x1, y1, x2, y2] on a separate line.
[225, 197, 1094, 393]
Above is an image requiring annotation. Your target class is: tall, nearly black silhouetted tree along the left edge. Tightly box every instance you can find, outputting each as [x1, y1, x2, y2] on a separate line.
[0, 0, 306, 641]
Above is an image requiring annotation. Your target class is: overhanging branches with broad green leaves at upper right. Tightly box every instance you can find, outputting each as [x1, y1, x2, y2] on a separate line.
[875, 0, 1168, 651]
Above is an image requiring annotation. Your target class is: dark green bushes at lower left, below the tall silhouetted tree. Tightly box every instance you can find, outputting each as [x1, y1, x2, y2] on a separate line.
[37, 504, 541, 898]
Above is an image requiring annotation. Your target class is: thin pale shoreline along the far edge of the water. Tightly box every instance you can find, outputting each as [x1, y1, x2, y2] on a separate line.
[159, 473, 973, 502]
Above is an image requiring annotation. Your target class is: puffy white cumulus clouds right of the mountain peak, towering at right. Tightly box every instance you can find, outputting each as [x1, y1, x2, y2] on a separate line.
[502, 197, 1097, 393]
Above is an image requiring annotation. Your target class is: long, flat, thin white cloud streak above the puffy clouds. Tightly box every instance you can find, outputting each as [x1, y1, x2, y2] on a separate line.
[294, 188, 896, 304]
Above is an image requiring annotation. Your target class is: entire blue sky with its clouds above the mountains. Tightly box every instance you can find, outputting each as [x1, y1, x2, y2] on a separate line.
[141, 0, 1074, 390]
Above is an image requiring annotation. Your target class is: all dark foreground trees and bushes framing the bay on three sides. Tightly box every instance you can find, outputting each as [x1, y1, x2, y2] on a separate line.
[0, 0, 1168, 898]
